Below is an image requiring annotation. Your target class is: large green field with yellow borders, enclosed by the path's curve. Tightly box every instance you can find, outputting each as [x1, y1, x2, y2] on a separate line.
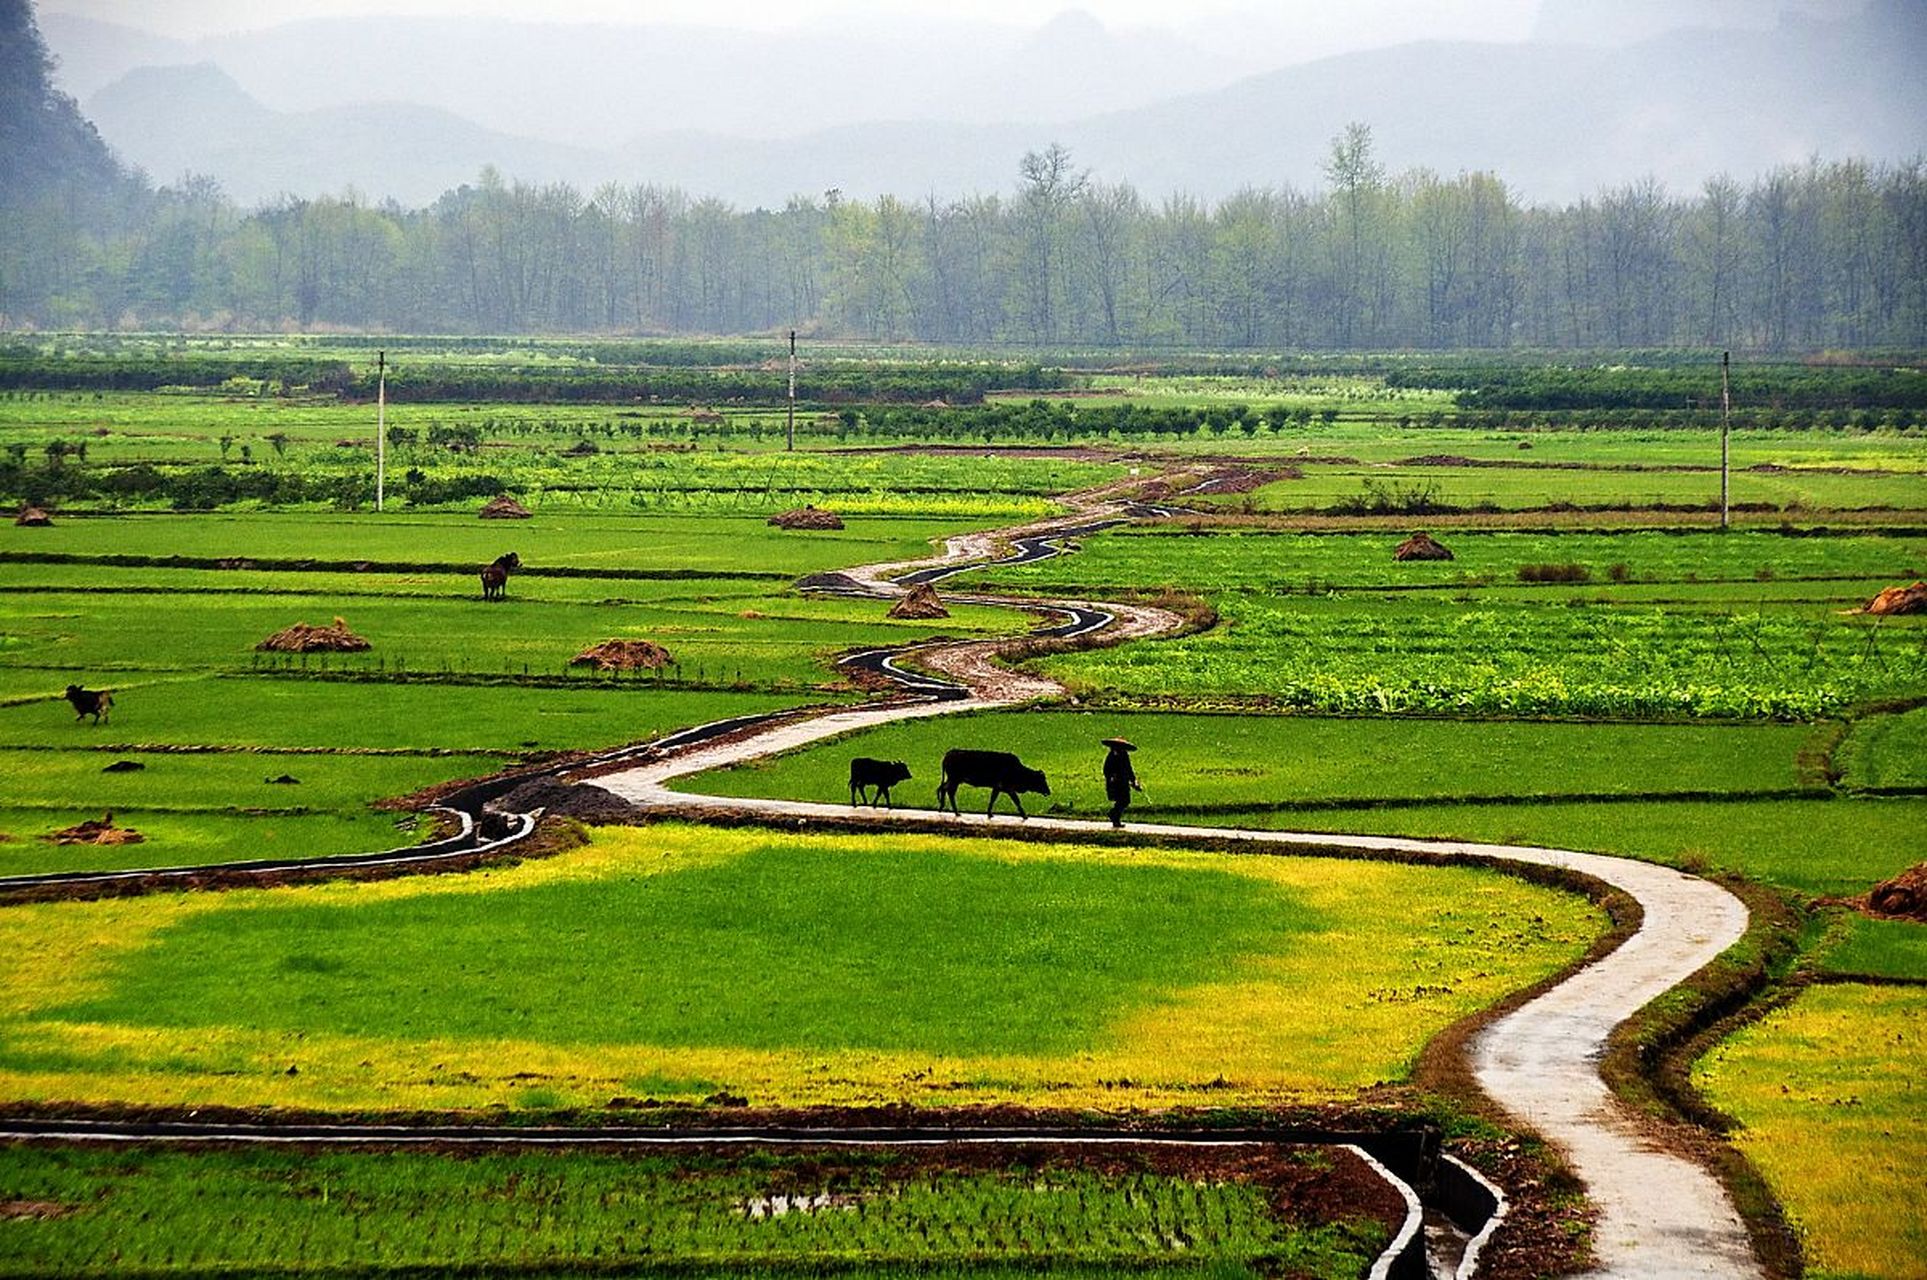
[0, 825, 1603, 1112]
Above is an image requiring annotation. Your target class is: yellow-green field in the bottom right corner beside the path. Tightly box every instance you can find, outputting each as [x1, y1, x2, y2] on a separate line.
[1694, 983, 1927, 1280]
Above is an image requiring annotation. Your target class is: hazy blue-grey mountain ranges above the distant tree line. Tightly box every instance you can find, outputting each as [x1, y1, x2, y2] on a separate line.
[42, 0, 1927, 206]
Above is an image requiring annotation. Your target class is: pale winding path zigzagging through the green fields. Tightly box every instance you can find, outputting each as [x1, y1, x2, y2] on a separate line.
[594, 485, 1761, 1280]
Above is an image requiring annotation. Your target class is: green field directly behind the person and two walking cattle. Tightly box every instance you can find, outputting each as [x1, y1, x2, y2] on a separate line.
[676, 711, 1927, 896]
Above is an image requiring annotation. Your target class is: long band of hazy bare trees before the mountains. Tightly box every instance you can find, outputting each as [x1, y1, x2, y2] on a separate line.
[0, 116, 1927, 351]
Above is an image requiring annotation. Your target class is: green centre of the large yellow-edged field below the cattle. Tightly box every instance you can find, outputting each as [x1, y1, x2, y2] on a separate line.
[64, 842, 1324, 1056]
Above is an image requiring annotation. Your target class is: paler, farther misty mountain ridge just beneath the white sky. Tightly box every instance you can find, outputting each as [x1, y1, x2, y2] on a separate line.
[48, 12, 1264, 147]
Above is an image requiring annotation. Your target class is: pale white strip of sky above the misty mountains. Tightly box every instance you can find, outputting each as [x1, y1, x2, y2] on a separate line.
[42, 0, 1538, 44]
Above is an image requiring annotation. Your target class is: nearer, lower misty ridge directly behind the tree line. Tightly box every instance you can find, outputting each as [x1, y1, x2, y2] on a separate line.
[75, 0, 1927, 206]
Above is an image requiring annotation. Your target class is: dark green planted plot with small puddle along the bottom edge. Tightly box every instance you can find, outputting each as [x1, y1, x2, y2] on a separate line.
[0, 1145, 1386, 1280]
